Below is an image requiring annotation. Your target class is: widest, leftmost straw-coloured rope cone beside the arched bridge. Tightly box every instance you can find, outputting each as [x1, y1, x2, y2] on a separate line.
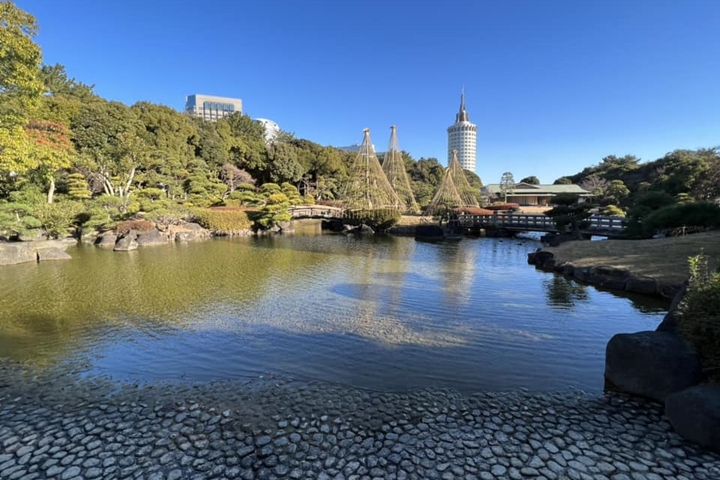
[342, 128, 402, 210]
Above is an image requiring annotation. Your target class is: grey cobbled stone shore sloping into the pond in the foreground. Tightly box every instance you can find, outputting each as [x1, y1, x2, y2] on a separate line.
[0, 365, 720, 480]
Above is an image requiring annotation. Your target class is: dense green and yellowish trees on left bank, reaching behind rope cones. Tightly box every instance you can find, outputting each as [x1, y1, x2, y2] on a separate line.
[0, 2, 482, 238]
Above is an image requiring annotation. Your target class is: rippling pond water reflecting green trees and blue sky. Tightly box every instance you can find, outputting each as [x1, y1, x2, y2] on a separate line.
[0, 222, 668, 393]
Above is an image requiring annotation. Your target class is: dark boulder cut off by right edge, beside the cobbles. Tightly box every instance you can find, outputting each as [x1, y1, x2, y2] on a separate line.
[665, 385, 720, 452]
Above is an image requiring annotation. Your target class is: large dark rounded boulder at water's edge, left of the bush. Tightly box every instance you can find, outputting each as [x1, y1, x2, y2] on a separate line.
[605, 332, 702, 402]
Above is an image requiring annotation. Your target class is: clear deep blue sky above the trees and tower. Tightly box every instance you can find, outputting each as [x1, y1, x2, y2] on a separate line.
[16, 0, 720, 183]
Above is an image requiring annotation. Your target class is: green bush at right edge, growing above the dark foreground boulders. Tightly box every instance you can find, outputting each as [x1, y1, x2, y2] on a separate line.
[678, 254, 720, 383]
